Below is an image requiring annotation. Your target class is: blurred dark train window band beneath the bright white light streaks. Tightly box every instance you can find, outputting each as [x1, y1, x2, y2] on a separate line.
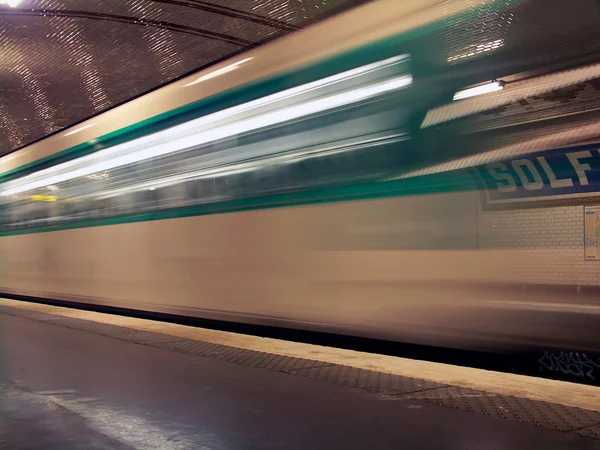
[0, 75, 410, 229]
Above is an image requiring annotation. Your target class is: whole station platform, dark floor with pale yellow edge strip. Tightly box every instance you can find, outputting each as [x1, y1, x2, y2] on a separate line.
[0, 300, 600, 450]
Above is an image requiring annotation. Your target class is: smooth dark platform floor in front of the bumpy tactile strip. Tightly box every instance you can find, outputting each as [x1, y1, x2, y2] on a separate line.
[0, 315, 600, 450]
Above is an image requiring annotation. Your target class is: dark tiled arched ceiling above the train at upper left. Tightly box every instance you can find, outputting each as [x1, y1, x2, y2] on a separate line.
[0, 0, 365, 156]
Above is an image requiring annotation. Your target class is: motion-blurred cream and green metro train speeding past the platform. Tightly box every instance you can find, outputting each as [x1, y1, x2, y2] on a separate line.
[0, 0, 600, 366]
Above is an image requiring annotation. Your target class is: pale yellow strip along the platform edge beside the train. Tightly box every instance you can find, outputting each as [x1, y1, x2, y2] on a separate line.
[0, 299, 600, 411]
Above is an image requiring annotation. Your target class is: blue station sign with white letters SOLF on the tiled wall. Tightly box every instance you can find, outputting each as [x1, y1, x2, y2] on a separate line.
[477, 144, 600, 205]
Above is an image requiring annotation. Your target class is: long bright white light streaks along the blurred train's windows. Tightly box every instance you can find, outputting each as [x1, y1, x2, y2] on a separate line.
[1, 56, 412, 196]
